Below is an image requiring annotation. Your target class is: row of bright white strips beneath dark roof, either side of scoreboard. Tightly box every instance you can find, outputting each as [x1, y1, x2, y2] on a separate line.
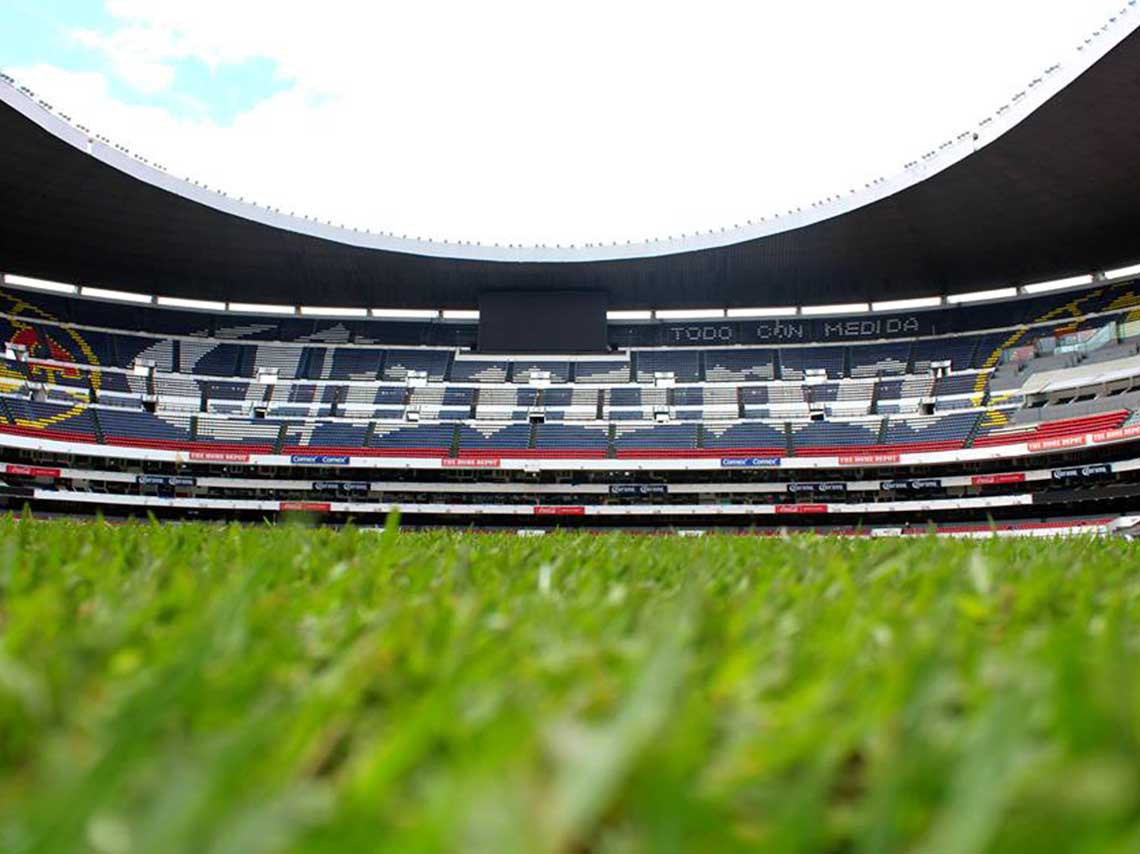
[3, 263, 1140, 320]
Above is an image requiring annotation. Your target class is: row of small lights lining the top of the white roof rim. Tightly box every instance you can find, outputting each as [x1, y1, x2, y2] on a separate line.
[0, 0, 1138, 253]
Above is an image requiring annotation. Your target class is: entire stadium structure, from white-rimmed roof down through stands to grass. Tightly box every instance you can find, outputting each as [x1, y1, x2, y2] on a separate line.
[0, 3, 1140, 535]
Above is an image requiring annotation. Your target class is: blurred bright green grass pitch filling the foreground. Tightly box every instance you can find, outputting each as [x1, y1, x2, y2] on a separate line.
[0, 520, 1140, 854]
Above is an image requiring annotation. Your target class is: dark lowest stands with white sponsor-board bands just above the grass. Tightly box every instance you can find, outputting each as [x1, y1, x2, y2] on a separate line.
[0, 428, 1140, 532]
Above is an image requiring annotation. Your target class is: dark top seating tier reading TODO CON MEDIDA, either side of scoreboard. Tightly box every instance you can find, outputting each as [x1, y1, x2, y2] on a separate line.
[0, 278, 1140, 348]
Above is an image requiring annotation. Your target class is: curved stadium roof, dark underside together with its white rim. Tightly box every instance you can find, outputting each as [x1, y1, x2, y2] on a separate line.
[0, 8, 1140, 309]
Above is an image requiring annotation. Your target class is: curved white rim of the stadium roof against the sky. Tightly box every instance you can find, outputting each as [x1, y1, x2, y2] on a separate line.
[0, 0, 1140, 263]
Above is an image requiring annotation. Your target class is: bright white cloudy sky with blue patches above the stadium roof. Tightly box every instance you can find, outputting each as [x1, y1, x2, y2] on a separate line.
[0, 0, 1135, 244]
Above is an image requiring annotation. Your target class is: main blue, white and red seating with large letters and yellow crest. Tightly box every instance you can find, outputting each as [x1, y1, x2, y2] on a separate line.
[0, 279, 1140, 476]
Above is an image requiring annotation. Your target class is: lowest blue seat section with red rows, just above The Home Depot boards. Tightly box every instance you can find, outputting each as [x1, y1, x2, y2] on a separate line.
[0, 395, 1140, 459]
